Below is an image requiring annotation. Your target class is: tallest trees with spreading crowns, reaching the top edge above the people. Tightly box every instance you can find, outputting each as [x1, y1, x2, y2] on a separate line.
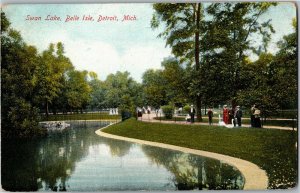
[151, 3, 276, 120]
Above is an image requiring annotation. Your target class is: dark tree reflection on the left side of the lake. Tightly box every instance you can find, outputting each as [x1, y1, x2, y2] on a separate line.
[1, 123, 107, 191]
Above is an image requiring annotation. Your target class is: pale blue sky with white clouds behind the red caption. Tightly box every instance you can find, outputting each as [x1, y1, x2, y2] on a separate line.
[2, 3, 296, 82]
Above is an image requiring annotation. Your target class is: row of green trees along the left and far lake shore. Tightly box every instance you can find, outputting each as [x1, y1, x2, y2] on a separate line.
[1, 12, 142, 137]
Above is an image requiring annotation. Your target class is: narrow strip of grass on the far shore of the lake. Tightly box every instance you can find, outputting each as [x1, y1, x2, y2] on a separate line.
[42, 113, 121, 121]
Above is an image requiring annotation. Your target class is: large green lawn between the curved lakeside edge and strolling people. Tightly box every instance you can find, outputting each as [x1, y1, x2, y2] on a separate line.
[103, 119, 298, 189]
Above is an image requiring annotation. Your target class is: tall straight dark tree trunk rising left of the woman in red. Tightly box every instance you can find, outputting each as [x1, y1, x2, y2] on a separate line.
[195, 3, 202, 121]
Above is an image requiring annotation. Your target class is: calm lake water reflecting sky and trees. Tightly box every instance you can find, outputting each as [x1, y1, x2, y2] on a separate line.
[1, 122, 244, 192]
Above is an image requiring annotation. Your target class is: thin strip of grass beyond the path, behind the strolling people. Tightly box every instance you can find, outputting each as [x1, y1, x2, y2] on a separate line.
[154, 117, 297, 127]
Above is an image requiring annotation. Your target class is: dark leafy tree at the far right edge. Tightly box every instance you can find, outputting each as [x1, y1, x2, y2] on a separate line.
[238, 17, 298, 116]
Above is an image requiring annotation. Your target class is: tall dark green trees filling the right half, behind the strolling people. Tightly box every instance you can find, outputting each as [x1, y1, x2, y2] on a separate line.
[146, 2, 297, 117]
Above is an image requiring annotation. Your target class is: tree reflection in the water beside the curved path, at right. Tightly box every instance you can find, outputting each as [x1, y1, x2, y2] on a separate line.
[142, 146, 244, 190]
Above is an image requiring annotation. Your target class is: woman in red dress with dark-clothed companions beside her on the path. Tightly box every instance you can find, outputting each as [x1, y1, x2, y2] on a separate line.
[223, 105, 243, 127]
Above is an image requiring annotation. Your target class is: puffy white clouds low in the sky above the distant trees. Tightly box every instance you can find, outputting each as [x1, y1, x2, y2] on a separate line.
[64, 37, 170, 81]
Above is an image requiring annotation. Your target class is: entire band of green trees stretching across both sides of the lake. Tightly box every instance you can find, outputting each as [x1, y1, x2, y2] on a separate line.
[1, 2, 298, 136]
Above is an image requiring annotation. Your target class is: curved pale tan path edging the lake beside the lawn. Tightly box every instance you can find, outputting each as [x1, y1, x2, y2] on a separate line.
[95, 125, 268, 190]
